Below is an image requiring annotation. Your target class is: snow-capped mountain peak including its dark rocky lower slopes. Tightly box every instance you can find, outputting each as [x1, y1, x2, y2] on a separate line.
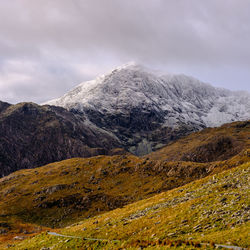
[47, 64, 250, 155]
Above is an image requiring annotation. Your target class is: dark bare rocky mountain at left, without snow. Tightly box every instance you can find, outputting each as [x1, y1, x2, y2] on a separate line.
[0, 102, 119, 176]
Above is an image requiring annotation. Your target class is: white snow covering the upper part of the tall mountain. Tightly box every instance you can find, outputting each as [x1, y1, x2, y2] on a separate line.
[47, 64, 250, 127]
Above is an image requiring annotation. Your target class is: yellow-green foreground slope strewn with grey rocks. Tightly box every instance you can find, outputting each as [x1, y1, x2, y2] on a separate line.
[10, 163, 250, 249]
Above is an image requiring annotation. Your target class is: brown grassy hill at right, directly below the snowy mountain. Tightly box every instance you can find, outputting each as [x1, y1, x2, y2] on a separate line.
[147, 121, 250, 162]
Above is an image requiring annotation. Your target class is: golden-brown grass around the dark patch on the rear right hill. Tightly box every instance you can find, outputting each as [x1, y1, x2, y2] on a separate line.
[145, 121, 250, 161]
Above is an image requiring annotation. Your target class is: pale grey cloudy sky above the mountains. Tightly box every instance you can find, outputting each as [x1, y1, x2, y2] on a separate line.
[0, 0, 250, 103]
